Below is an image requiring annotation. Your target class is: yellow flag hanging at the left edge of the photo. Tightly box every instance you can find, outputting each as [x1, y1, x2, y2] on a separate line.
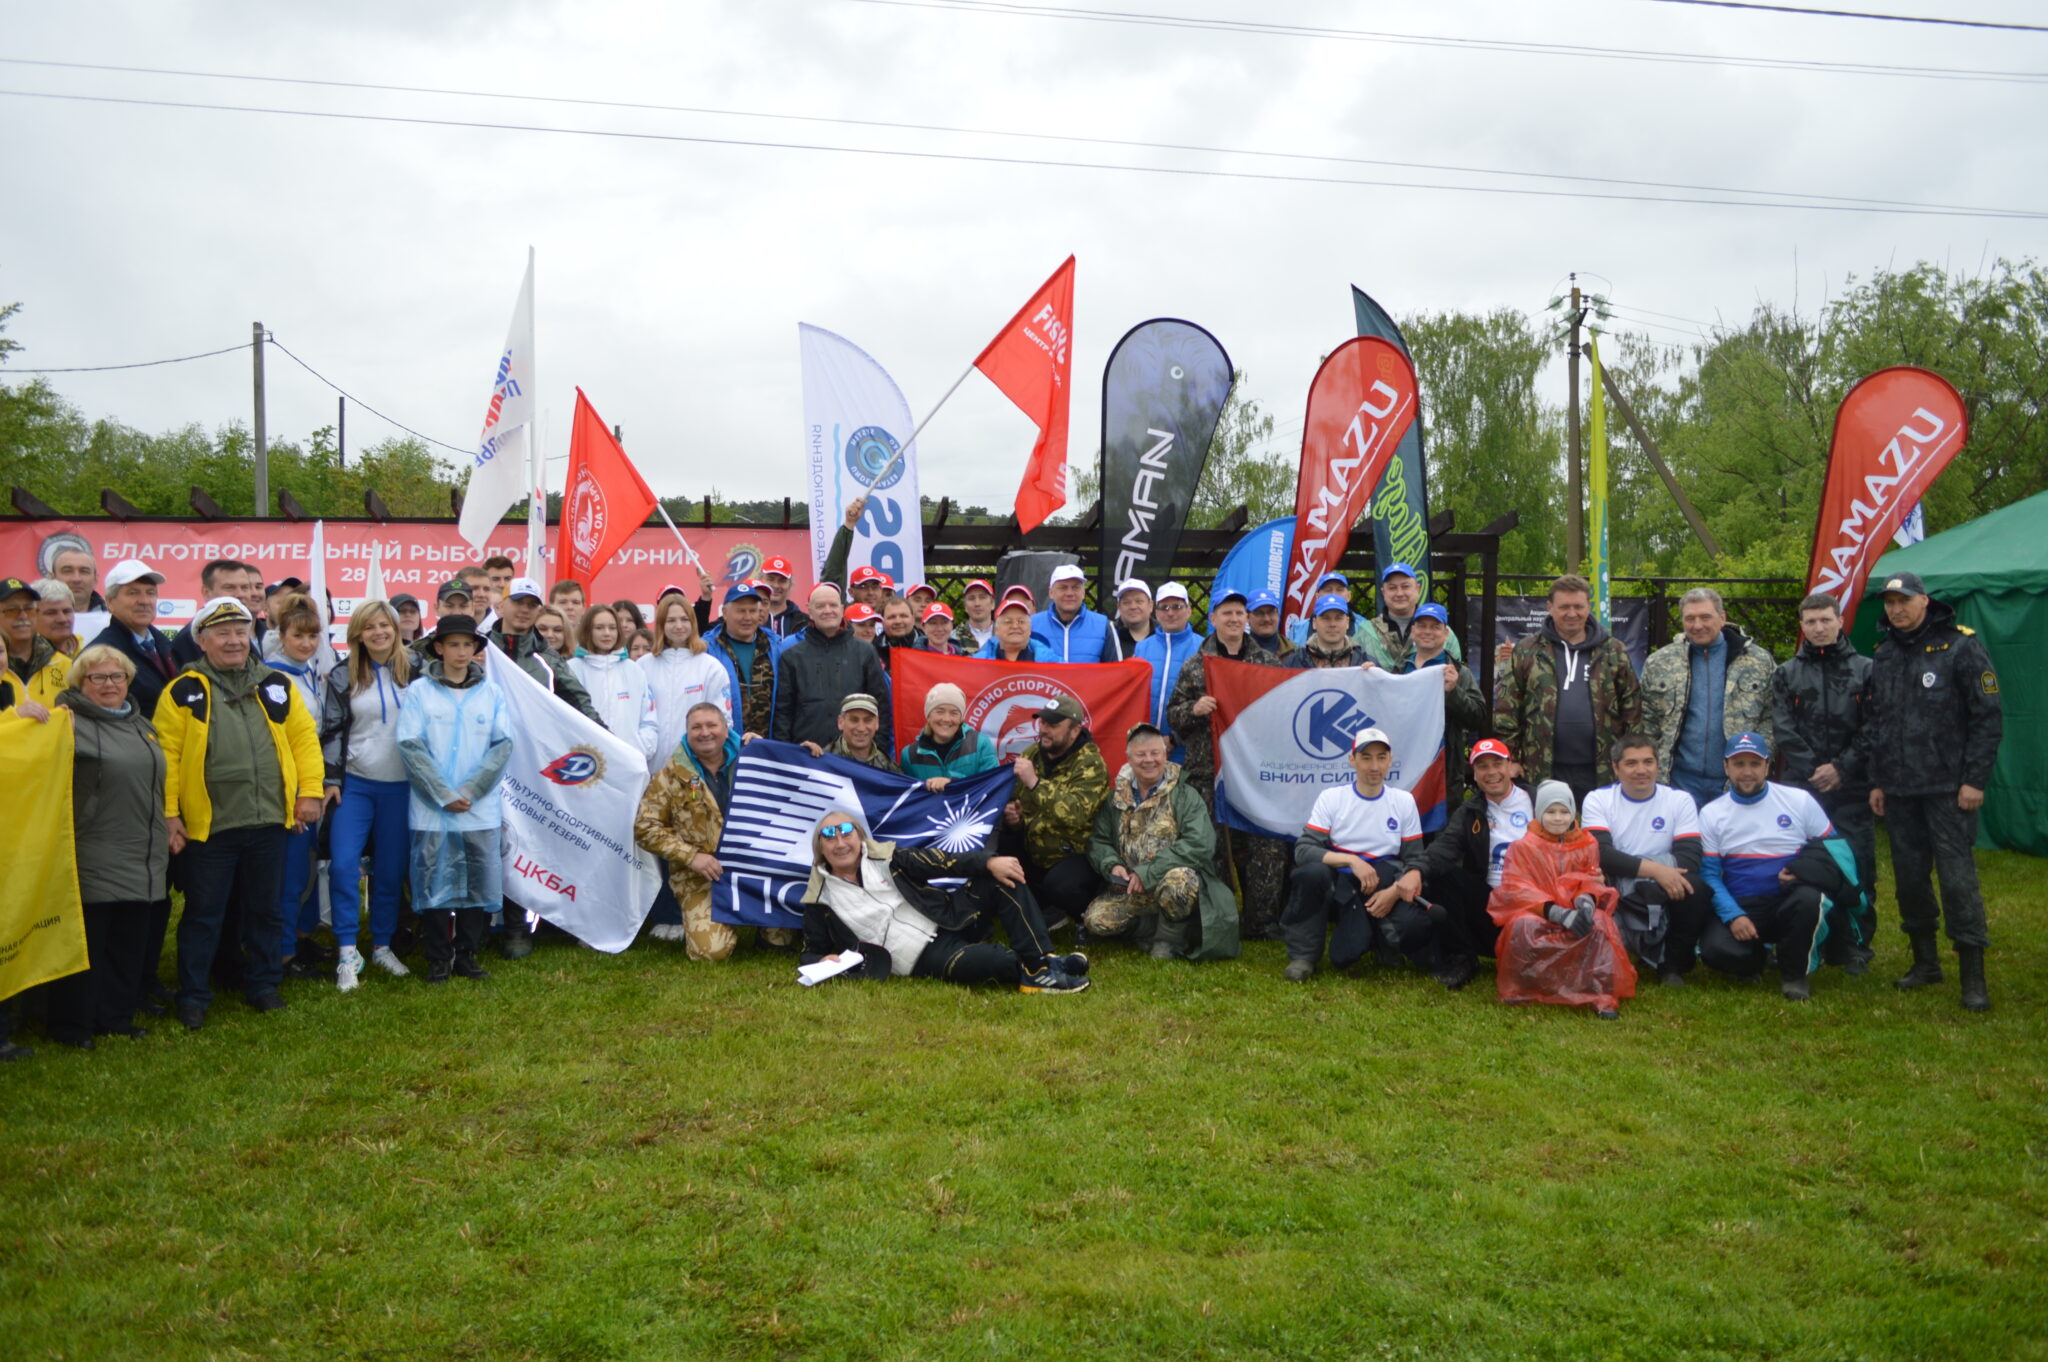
[0, 709, 86, 999]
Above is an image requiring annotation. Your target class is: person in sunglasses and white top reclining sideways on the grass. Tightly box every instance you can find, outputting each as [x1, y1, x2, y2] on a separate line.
[803, 809, 1087, 993]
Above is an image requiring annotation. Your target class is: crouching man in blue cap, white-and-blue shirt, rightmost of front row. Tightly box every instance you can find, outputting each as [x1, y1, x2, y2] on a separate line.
[1700, 733, 1855, 1002]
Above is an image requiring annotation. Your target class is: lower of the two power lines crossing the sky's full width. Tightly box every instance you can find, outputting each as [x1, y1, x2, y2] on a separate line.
[0, 90, 2048, 221]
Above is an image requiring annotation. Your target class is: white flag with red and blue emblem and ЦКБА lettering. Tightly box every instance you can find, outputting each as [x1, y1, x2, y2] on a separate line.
[485, 649, 659, 952]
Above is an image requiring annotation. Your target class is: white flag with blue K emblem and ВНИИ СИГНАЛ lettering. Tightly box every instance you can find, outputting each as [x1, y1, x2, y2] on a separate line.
[1210, 662, 1444, 838]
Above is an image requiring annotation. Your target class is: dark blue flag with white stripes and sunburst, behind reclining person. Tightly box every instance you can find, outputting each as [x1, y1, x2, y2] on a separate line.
[711, 737, 1016, 928]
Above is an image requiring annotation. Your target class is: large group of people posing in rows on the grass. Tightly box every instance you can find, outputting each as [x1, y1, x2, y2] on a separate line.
[0, 524, 1999, 1057]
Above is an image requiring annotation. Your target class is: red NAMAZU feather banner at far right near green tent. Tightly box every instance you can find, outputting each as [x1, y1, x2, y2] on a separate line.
[1806, 365, 1970, 621]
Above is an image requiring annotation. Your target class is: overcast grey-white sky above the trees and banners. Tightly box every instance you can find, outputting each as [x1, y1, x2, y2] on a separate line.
[0, 0, 2048, 508]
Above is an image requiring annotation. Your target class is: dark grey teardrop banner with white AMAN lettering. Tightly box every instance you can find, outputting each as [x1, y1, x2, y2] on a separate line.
[1096, 317, 1231, 598]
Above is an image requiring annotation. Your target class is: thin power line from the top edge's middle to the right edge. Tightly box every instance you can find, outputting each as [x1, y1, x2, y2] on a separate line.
[854, 0, 2048, 84]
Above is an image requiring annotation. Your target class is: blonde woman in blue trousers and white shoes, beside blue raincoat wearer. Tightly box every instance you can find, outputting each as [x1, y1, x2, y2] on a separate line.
[319, 600, 412, 991]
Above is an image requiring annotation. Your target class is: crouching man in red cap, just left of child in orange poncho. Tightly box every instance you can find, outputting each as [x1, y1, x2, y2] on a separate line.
[1421, 737, 1536, 989]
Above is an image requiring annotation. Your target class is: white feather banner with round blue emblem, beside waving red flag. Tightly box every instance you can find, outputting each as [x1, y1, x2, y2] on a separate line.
[797, 322, 924, 590]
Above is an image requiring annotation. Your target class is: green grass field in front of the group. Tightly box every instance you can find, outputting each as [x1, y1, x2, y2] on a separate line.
[0, 852, 2048, 1362]
